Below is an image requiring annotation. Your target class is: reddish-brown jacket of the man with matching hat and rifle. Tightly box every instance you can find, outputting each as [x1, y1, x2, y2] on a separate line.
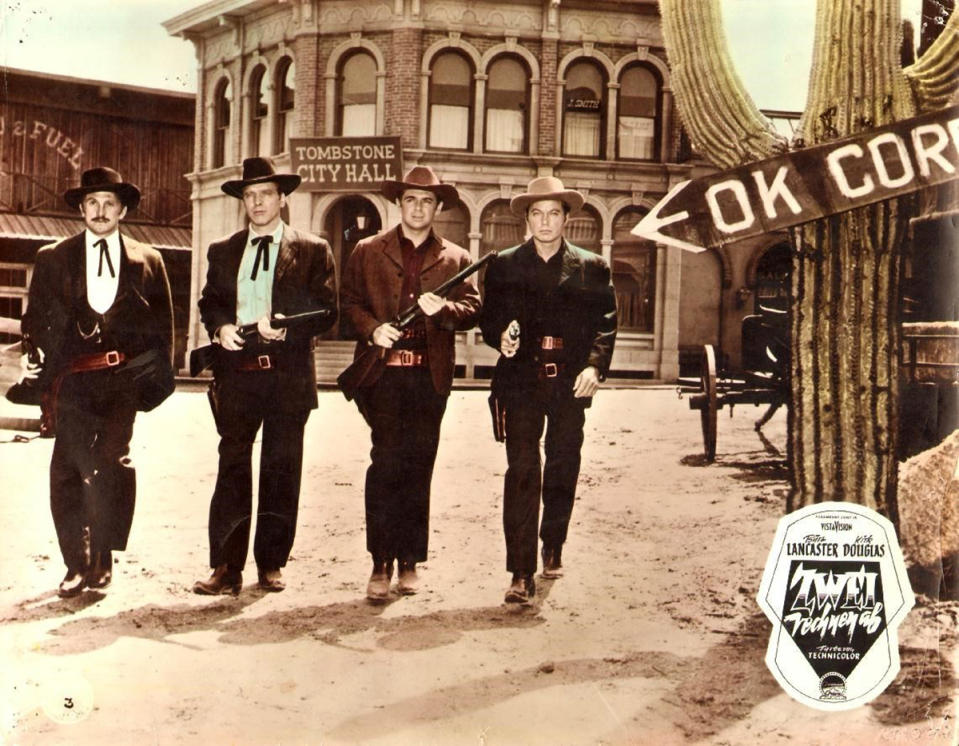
[340, 227, 480, 395]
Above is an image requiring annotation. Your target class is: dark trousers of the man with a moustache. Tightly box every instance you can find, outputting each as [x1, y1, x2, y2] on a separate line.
[50, 371, 136, 571]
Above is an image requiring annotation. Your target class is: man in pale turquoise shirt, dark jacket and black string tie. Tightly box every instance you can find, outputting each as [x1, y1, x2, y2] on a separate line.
[193, 158, 336, 595]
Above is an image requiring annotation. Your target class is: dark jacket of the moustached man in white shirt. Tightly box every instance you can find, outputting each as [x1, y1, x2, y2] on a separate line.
[22, 232, 173, 376]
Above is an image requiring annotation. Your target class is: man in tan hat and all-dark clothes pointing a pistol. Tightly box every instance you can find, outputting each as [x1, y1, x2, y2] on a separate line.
[480, 176, 616, 603]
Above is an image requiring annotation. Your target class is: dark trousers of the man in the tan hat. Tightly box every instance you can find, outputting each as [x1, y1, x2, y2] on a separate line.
[503, 381, 586, 574]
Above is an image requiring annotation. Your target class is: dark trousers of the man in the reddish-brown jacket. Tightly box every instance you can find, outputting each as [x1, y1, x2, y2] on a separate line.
[361, 367, 447, 562]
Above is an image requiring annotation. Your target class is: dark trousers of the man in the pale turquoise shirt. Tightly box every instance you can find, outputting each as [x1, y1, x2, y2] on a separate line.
[209, 371, 310, 569]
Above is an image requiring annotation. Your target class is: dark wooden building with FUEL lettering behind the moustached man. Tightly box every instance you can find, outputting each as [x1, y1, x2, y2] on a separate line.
[0, 68, 194, 366]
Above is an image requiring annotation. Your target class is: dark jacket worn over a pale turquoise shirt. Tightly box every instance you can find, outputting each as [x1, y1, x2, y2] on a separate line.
[199, 225, 336, 409]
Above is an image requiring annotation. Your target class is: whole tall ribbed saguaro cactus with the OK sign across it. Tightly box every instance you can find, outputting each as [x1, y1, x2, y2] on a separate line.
[660, 0, 959, 522]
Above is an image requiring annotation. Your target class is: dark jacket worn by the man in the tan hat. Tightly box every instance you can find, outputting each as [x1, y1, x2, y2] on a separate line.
[479, 239, 616, 395]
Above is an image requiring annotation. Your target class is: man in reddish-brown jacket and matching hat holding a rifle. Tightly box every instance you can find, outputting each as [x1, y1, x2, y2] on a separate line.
[340, 166, 480, 602]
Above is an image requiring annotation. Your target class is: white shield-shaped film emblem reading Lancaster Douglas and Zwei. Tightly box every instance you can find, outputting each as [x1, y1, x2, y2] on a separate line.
[757, 503, 914, 710]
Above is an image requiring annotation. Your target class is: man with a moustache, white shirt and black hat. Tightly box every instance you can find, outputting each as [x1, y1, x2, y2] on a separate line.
[22, 168, 173, 598]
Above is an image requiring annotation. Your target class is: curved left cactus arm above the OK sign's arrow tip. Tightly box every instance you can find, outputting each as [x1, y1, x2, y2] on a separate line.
[660, 0, 787, 168]
